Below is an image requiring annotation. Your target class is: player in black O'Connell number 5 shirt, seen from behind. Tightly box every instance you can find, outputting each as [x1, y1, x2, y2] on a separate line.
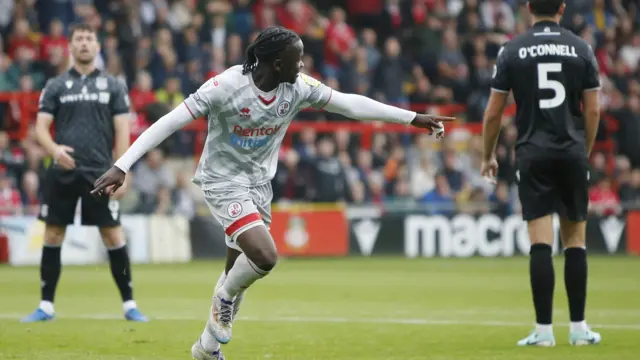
[482, 0, 601, 346]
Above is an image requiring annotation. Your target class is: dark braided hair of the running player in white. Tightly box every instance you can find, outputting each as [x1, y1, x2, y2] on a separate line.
[242, 26, 300, 74]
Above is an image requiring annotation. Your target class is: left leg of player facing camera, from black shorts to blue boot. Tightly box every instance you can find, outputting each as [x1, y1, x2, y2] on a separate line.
[22, 169, 78, 322]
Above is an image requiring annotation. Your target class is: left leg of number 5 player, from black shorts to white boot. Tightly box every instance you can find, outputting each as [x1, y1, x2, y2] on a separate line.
[517, 161, 556, 346]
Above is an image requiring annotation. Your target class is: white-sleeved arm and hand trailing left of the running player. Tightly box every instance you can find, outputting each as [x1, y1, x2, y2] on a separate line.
[91, 103, 194, 195]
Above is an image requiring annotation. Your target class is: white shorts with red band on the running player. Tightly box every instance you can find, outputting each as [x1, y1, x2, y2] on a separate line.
[204, 183, 273, 251]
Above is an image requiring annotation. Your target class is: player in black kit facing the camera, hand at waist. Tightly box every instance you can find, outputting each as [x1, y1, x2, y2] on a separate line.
[22, 25, 147, 322]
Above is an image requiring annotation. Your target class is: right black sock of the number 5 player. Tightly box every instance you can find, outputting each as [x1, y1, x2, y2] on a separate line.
[564, 248, 587, 322]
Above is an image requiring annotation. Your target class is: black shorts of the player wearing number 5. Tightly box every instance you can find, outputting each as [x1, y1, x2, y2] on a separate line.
[516, 155, 589, 221]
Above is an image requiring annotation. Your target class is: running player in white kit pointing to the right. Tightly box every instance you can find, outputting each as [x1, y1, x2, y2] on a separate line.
[92, 27, 452, 360]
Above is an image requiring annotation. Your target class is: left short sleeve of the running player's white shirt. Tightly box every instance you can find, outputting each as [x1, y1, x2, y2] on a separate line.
[184, 73, 228, 119]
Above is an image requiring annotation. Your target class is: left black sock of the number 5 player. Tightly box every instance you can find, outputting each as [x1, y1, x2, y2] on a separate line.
[529, 244, 556, 325]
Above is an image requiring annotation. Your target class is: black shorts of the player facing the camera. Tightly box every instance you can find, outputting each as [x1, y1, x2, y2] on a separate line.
[39, 168, 120, 227]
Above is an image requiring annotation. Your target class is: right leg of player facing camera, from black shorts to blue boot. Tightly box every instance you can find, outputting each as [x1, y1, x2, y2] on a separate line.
[82, 186, 148, 322]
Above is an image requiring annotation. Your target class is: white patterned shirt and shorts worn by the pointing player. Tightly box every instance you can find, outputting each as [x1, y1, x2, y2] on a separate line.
[185, 66, 332, 250]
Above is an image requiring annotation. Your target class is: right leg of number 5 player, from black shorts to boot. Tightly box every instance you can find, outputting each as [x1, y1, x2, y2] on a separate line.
[560, 159, 602, 345]
